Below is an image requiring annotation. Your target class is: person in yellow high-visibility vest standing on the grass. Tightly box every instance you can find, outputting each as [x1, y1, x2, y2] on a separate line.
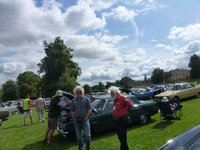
[23, 95, 33, 125]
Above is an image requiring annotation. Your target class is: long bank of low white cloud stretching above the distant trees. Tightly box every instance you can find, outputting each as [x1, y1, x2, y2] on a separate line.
[80, 41, 200, 84]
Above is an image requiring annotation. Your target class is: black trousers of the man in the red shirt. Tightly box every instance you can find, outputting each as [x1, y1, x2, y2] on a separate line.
[115, 117, 129, 150]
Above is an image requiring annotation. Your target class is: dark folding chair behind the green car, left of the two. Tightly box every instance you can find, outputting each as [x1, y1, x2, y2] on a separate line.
[156, 102, 177, 121]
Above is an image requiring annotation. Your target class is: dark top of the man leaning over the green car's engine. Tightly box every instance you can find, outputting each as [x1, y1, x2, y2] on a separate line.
[48, 96, 60, 119]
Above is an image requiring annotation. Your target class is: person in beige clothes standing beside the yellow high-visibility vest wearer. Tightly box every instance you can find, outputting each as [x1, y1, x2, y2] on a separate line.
[35, 95, 46, 123]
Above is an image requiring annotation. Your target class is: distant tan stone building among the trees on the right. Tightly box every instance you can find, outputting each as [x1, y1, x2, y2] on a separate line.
[165, 69, 190, 82]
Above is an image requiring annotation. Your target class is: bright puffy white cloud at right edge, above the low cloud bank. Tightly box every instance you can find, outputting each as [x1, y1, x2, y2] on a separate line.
[168, 23, 200, 41]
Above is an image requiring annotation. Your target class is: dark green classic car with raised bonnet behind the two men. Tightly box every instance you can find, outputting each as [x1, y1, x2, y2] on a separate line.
[57, 95, 158, 136]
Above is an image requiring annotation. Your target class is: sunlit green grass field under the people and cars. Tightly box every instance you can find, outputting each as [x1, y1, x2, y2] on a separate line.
[0, 98, 200, 150]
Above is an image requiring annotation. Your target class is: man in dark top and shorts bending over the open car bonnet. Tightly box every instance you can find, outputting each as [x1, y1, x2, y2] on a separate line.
[43, 90, 63, 145]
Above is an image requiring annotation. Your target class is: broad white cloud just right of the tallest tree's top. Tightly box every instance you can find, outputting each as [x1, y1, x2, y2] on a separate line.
[65, 34, 127, 61]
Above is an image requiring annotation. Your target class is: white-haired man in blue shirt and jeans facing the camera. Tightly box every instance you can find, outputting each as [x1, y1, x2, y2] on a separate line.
[71, 86, 92, 150]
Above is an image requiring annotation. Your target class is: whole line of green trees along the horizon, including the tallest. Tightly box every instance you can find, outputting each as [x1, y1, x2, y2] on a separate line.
[0, 37, 200, 101]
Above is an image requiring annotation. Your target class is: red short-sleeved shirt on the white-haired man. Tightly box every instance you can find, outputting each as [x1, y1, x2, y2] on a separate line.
[112, 94, 132, 120]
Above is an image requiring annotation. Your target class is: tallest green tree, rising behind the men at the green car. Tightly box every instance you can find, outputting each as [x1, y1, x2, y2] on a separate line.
[38, 37, 81, 96]
